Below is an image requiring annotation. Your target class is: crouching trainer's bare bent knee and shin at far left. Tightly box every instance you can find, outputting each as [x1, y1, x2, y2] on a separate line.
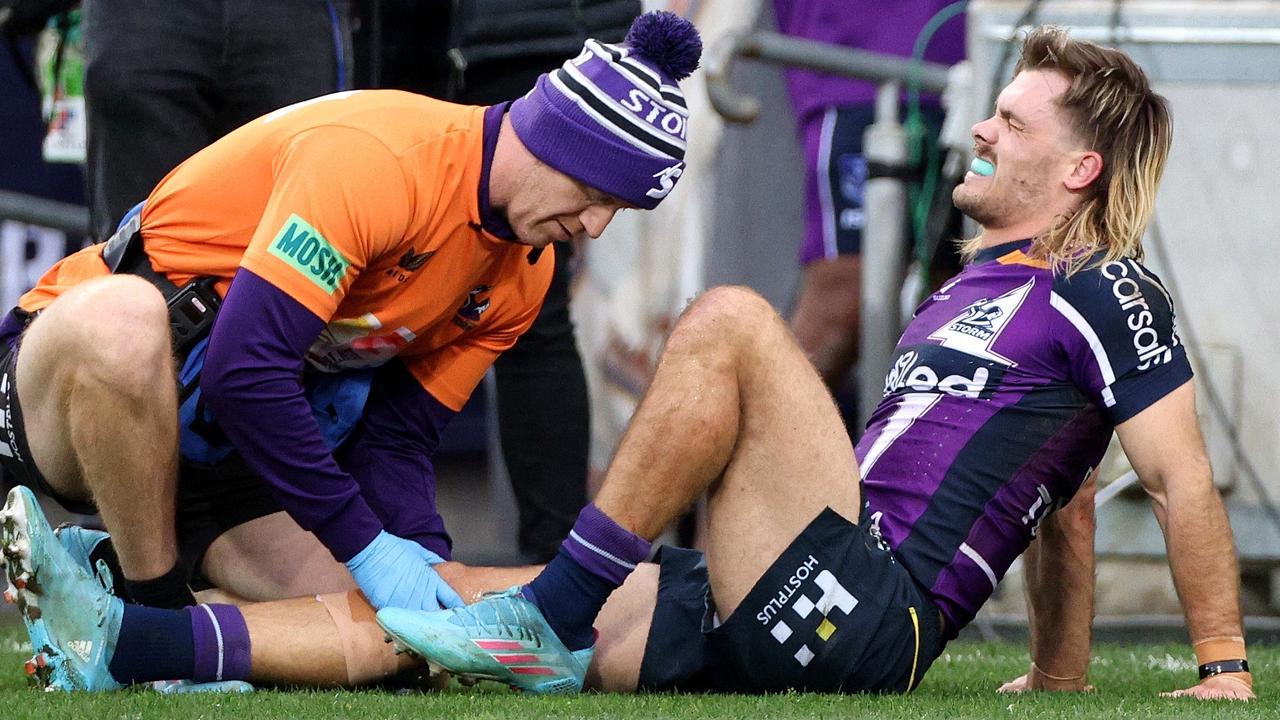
[17, 275, 185, 594]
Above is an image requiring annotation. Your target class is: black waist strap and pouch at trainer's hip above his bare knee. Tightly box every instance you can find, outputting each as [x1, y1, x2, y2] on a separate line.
[102, 214, 223, 357]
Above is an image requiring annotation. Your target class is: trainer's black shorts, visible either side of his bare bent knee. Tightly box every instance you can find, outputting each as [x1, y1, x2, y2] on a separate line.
[0, 330, 283, 589]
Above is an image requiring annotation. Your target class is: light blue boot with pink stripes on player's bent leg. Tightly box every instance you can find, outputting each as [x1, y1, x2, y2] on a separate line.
[378, 587, 595, 693]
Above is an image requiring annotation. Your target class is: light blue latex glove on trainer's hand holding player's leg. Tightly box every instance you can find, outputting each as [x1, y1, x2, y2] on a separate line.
[347, 530, 465, 610]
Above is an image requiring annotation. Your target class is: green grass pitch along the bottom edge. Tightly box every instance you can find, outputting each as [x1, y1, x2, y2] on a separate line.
[0, 626, 1280, 720]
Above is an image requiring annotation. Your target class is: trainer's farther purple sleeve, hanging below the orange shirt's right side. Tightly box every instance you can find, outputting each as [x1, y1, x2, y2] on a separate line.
[337, 360, 454, 560]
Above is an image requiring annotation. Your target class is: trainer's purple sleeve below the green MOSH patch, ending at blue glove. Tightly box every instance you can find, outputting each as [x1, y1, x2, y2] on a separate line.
[200, 269, 383, 562]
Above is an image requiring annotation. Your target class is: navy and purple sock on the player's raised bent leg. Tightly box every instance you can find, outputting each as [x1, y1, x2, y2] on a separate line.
[522, 505, 650, 650]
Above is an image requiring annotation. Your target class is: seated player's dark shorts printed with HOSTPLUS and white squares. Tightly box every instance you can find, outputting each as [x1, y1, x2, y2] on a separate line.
[639, 509, 945, 693]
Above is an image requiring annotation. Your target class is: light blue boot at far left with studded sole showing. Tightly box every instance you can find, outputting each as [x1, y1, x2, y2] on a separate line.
[0, 486, 124, 692]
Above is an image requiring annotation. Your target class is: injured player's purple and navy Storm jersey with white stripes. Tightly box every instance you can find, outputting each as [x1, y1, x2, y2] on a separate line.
[856, 241, 1192, 637]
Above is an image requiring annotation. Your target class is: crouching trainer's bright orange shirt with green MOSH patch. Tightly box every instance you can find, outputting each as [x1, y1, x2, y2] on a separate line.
[19, 90, 553, 410]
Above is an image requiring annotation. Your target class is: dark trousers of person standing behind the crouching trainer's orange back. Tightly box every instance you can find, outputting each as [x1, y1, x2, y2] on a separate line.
[84, 0, 351, 240]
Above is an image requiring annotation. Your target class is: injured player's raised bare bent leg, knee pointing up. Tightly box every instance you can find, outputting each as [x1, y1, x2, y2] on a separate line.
[595, 287, 859, 616]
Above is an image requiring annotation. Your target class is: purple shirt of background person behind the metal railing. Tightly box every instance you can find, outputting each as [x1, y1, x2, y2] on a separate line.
[773, 0, 965, 127]
